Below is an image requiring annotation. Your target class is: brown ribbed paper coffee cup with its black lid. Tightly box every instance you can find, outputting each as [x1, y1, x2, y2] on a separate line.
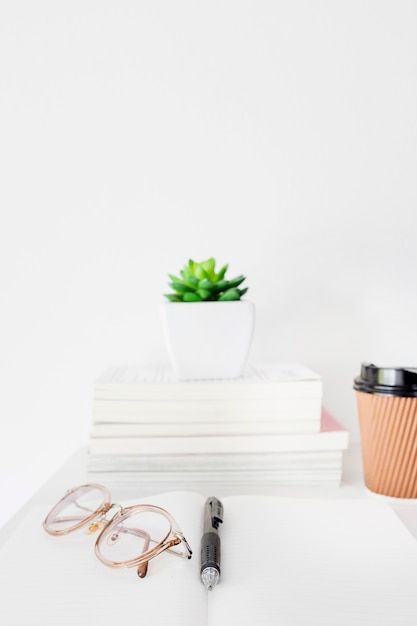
[353, 363, 417, 498]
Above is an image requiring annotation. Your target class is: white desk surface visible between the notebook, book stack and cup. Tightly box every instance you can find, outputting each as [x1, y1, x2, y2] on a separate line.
[0, 444, 417, 545]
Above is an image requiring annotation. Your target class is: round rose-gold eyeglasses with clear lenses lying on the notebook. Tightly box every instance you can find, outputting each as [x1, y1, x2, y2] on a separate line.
[43, 483, 192, 578]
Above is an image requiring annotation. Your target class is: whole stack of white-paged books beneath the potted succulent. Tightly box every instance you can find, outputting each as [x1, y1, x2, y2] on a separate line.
[88, 363, 348, 487]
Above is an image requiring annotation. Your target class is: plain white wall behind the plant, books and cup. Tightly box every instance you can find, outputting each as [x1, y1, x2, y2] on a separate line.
[0, 0, 417, 521]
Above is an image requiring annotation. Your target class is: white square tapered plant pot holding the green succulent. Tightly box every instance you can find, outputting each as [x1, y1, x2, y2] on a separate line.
[162, 300, 255, 380]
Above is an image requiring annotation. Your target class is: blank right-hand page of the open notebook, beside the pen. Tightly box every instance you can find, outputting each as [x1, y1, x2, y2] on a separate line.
[209, 497, 417, 626]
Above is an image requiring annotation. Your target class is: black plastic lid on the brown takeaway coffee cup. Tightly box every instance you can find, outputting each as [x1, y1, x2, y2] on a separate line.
[353, 363, 417, 398]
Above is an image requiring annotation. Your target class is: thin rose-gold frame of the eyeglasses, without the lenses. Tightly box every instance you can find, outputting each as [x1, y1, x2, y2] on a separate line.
[42, 483, 192, 578]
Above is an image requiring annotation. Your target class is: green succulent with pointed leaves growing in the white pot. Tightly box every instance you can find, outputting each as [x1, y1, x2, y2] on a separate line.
[164, 258, 248, 302]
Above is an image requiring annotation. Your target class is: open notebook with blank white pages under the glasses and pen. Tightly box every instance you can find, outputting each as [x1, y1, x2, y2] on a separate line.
[0, 492, 417, 626]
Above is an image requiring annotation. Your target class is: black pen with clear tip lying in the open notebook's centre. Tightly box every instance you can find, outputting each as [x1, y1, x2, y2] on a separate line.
[200, 497, 223, 591]
